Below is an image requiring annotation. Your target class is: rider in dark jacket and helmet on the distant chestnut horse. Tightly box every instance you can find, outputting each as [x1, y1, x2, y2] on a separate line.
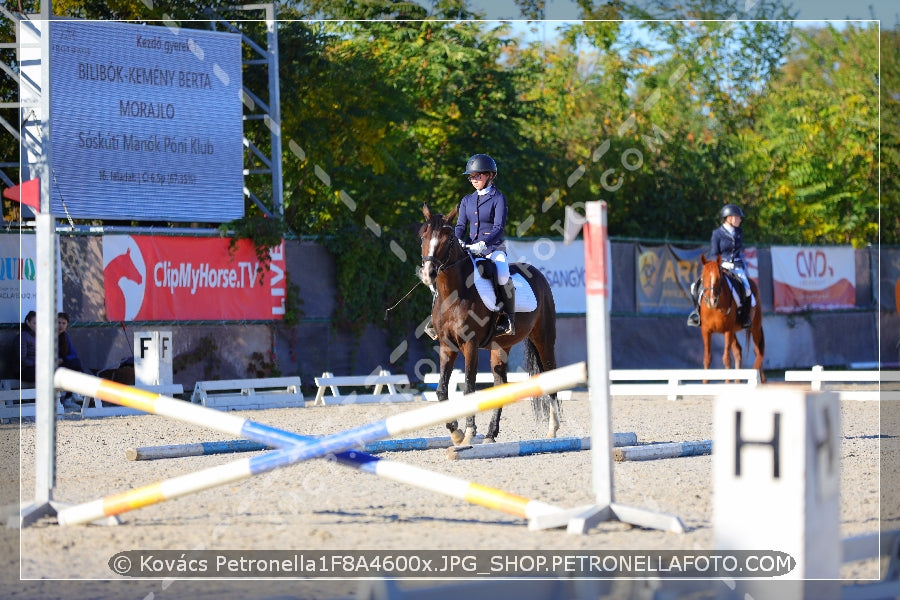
[688, 204, 755, 329]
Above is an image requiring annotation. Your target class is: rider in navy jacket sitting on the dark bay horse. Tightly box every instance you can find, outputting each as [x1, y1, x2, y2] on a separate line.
[456, 154, 516, 335]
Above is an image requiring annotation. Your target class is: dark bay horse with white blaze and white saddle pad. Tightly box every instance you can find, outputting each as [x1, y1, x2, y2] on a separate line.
[419, 205, 559, 444]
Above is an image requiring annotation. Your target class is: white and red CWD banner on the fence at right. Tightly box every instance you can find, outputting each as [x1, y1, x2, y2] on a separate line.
[772, 246, 856, 313]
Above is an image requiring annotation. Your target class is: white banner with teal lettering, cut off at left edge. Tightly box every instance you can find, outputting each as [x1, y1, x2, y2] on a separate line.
[0, 234, 62, 323]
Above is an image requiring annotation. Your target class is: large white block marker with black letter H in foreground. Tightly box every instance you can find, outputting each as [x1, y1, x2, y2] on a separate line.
[713, 384, 841, 598]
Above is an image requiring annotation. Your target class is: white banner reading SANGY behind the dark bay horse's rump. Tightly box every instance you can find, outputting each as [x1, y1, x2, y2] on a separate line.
[506, 239, 592, 314]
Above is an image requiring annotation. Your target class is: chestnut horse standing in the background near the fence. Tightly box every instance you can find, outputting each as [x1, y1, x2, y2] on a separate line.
[699, 255, 766, 382]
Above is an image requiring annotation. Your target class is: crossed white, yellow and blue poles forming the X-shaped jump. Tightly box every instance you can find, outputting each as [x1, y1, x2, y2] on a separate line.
[54, 363, 587, 528]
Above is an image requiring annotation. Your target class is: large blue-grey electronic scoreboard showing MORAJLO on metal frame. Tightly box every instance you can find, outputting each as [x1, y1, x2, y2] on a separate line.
[20, 20, 244, 222]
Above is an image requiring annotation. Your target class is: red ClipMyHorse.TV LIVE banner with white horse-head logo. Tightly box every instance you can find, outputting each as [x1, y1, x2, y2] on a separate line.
[103, 235, 287, 321]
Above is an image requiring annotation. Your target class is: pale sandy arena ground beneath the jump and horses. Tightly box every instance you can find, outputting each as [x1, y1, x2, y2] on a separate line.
[0, 392, 884, 600]
